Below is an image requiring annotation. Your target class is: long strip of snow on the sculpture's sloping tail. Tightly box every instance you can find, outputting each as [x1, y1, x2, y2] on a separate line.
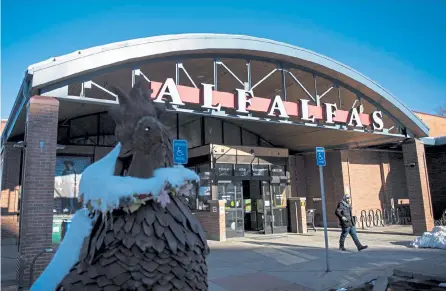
[31, 209, 92, 291]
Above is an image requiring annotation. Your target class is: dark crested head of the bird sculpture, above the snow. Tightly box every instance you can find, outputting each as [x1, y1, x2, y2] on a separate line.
[109, 80, 173, 178]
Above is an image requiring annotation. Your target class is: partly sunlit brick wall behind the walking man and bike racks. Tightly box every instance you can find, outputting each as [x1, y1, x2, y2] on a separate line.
[302, 150, 408, 227]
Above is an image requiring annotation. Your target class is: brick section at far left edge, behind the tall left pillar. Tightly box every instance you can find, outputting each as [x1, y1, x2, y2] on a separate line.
[1, 143, 22, 239]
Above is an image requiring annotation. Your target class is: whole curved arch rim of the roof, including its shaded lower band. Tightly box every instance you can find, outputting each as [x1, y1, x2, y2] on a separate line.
[5, 34, 429, 146]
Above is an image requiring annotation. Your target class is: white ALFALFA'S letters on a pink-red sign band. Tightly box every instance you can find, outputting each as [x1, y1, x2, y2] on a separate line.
[150, 78, 384, 130]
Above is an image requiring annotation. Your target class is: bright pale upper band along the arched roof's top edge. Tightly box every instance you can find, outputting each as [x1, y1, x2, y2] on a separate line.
[7, 33, 429, 137]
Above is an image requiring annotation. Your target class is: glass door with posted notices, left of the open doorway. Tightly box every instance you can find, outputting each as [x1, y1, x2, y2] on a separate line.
[217, 181, 244, 238]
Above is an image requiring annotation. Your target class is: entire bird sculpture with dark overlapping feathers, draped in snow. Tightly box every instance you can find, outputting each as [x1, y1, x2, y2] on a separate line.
[31, 82, 209, 291]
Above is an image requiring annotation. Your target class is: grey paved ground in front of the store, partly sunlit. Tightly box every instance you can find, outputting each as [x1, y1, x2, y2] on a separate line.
[208, 227, 446, 291]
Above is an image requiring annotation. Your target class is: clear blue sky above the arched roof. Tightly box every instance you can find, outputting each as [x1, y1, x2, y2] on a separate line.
[1, 0, 446, 118]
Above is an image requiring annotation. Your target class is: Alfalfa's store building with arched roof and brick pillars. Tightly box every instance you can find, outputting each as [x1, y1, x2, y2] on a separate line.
[2, 34, 446, 282]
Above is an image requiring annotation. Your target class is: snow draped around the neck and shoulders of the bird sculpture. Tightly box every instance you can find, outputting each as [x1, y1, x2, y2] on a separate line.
[79, 144, 199, 212]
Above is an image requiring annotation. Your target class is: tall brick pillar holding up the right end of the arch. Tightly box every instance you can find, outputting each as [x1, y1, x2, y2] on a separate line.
[403, 140, 434, 235]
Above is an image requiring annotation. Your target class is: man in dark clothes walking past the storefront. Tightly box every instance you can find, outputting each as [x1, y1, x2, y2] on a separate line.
[335, 195, 368, 251]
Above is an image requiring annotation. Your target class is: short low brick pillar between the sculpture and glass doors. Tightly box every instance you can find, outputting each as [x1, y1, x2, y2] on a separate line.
[194, 200, 226, 241]
